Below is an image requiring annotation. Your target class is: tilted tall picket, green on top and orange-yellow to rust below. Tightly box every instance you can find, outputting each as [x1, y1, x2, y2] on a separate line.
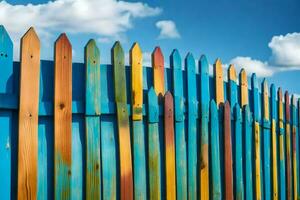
[112, 42, 133, 200]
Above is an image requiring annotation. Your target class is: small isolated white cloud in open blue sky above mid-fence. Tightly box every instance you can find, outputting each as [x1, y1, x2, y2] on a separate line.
[155, 20, 180, 39]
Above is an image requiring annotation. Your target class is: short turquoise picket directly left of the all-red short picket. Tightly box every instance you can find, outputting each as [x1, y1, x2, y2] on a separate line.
[210, 100, 222, 200]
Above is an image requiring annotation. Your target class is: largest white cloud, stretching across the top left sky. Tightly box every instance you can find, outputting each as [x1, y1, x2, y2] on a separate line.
[0, 0, 161, 37]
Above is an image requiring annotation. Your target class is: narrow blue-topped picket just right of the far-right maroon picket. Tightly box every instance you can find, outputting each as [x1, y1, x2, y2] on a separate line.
[291, 95, 298, 200]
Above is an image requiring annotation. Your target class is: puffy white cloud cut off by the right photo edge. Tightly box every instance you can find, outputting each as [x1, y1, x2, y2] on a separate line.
[268, 33, 300, 67]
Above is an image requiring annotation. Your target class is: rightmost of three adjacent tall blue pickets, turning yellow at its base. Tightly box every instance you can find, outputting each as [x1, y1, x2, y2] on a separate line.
[198, 55, 210, 199]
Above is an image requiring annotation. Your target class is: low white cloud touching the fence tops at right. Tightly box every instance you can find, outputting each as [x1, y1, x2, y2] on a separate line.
[230, 56, 276, 77]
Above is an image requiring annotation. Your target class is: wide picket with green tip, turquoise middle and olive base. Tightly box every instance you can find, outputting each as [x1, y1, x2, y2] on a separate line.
[85, 40, 101, 199]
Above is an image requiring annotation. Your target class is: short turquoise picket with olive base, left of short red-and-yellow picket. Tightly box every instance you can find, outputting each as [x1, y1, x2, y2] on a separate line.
[148, 87, 162, 200]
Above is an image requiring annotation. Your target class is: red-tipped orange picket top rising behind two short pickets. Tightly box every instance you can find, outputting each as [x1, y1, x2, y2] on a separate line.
[152, 47, 165, 95]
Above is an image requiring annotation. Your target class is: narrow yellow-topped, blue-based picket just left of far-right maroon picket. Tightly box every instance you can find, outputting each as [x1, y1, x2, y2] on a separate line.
[278, 88, 286, 199]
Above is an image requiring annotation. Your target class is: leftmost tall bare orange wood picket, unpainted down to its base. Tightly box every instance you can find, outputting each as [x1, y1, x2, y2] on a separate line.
[18, 27, 40, 199]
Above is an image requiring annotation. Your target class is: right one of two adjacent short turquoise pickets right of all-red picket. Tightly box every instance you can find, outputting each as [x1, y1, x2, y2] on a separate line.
[243, 105, 255, 200]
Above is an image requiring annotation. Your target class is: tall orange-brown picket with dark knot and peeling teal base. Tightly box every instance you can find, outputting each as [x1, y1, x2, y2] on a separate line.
[54, 34, 72, 199]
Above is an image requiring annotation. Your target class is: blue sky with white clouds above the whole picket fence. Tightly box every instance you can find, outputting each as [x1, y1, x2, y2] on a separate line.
[0, 0, 300, 94]
